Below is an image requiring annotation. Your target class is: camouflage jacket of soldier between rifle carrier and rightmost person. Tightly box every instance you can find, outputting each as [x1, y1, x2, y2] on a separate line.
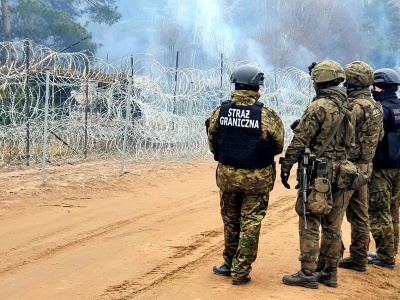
[348, 88, 384, 164]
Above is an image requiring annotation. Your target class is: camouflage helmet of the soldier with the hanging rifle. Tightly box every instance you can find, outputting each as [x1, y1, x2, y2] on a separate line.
[311, 60, 346, 83]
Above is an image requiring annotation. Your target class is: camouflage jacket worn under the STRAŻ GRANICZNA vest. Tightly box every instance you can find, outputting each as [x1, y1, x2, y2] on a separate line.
[208, 90, 284, 193]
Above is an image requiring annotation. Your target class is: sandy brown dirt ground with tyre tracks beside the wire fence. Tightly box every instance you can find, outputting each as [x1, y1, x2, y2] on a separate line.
[0, 160, 400, 300]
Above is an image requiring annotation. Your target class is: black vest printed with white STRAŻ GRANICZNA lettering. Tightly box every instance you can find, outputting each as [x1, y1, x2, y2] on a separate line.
[214, 100, 274, 169]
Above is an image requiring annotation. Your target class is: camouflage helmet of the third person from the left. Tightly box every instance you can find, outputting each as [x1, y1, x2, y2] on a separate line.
[345, 61, 374, 86]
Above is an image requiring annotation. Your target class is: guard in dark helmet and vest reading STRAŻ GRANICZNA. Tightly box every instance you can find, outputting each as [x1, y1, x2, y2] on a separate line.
[206, 64, 284, 285]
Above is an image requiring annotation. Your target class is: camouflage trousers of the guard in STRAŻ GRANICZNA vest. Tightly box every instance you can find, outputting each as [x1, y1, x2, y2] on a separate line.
[220, 191, 269, 280]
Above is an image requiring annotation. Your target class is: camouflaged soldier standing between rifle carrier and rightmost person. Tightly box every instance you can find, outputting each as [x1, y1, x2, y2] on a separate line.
[338, 61, 384, 272]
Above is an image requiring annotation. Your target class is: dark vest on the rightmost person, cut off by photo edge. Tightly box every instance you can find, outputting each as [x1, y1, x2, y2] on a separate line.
[373, 99, 400, 169]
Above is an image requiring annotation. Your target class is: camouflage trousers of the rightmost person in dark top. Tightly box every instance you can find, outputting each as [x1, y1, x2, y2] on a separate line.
[368, 169, 400, 263]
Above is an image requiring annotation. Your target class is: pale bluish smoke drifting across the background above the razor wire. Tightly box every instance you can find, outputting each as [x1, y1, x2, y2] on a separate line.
[88, 0, 400, 71]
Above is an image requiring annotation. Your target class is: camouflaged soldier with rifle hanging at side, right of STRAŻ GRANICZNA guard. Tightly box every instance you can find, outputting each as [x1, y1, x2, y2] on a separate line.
[280, 60, 354, 289]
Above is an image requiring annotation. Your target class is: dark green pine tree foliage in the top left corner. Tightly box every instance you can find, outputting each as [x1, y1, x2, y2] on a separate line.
[0, 0, 121, 53]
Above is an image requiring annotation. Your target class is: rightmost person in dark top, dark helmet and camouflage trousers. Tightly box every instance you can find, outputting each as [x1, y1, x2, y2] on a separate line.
[368, 68, 400, 269]
